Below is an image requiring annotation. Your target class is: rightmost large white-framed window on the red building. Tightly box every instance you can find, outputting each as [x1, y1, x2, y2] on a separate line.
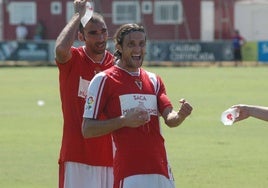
[154, 1, 183, 24]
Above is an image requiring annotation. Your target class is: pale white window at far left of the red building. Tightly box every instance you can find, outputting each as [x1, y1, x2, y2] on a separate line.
[9, 2, 37, 25]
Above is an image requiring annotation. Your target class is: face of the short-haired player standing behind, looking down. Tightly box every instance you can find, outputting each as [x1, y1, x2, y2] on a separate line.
[84, 22, 108, 54]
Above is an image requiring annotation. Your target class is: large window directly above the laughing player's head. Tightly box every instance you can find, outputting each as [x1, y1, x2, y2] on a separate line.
[112, 1, 141, 24]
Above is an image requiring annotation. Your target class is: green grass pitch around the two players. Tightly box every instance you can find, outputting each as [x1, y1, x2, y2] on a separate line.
[0, 66, 268, 188]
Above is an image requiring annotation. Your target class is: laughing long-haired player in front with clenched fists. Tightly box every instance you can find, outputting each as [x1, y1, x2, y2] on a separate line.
[82, 24, 192, 188]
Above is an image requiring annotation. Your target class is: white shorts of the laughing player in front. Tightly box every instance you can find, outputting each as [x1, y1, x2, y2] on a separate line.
[119, 174, 175, 188]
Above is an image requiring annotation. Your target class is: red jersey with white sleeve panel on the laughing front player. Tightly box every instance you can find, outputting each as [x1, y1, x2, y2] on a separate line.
[84, 66, 171, 185]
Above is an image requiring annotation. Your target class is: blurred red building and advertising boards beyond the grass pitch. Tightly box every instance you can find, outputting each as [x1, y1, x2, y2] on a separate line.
[0, 0, 268, 65]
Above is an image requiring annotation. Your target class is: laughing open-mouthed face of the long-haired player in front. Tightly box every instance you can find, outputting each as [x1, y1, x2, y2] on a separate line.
[121, 31, 146, 72]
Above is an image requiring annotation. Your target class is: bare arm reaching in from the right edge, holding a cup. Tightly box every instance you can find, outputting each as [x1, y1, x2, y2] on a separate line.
[232, 104, 268, 122]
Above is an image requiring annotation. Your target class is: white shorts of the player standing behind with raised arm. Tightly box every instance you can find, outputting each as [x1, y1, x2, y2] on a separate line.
[60, 162, 114, 188]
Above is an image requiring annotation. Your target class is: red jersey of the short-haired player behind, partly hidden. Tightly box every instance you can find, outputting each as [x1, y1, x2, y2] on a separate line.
[56, 47, 114, 166]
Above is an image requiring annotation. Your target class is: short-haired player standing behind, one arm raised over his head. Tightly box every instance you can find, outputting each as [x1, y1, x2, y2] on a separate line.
[55, 0, 114, 188]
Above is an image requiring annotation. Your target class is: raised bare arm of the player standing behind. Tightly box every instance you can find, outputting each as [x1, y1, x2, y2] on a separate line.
[55, 0, 87, 63]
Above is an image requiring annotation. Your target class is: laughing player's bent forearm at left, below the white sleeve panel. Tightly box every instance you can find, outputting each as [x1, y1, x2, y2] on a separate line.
[82, 116, 125, 138]
